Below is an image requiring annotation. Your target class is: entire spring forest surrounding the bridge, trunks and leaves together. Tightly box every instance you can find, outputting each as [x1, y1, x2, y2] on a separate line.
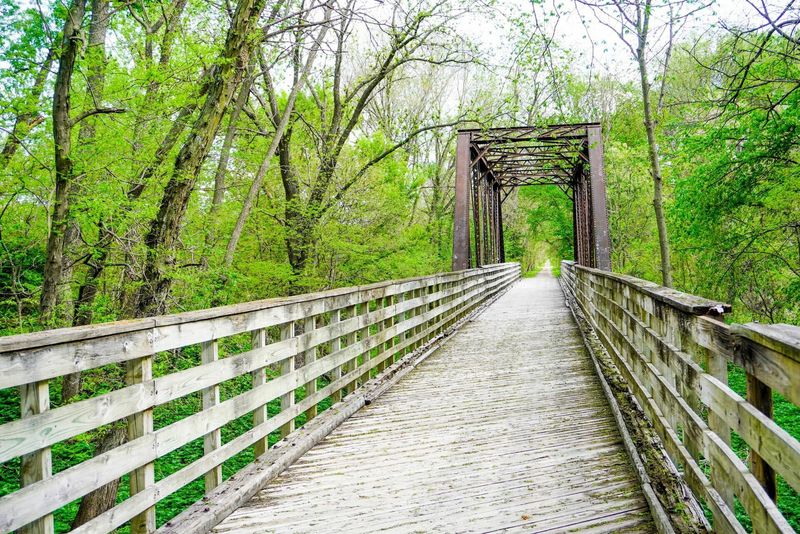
[0, 0, 800, 530]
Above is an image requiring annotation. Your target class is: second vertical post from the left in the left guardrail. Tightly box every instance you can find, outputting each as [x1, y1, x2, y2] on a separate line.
[126, 356, 156, 534]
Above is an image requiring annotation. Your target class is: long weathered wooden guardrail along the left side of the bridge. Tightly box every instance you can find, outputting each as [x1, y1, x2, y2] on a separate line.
[0, 263, 520, 533]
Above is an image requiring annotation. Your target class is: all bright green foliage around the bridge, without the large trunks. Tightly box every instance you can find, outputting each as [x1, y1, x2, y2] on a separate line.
[0, 0, 800, 530]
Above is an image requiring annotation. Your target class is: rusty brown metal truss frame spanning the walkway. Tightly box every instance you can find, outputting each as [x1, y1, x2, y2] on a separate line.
[453, 123, 611, 270]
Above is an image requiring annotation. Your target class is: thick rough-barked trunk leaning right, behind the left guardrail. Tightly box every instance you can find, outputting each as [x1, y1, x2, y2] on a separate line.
[136, 0, 266, 317]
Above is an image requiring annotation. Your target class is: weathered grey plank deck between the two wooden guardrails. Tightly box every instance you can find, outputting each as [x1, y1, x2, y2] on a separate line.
[215, 271, 654, 533]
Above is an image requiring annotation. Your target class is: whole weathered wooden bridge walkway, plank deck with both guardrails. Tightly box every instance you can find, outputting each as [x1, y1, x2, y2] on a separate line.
[0, 262, 800, 533]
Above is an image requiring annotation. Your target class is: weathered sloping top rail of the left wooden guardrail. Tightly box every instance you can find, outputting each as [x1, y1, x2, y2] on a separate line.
[0, 264, 512, 387]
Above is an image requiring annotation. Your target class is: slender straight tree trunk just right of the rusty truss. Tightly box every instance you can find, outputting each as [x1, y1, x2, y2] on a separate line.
[637, 27, 672, 287]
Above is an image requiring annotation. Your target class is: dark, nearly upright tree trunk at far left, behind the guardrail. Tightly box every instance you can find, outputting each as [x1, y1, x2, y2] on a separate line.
[40, 0, 86, 324]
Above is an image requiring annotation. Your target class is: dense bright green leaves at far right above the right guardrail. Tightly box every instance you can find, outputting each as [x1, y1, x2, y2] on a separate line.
[671, 34, 800, 324]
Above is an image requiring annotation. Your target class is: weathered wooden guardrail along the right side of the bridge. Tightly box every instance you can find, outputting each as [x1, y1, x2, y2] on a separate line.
[561, 262, 800, 533]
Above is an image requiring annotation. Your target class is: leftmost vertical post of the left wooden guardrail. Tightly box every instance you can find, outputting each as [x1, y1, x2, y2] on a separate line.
[19, 380, 55, 534]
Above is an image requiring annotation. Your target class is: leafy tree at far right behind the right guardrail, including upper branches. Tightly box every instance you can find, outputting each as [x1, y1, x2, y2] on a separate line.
[673, 2, 800, 323]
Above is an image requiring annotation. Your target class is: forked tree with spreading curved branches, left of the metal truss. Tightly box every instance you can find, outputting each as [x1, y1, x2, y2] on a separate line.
[269, 0, 469, 292]
